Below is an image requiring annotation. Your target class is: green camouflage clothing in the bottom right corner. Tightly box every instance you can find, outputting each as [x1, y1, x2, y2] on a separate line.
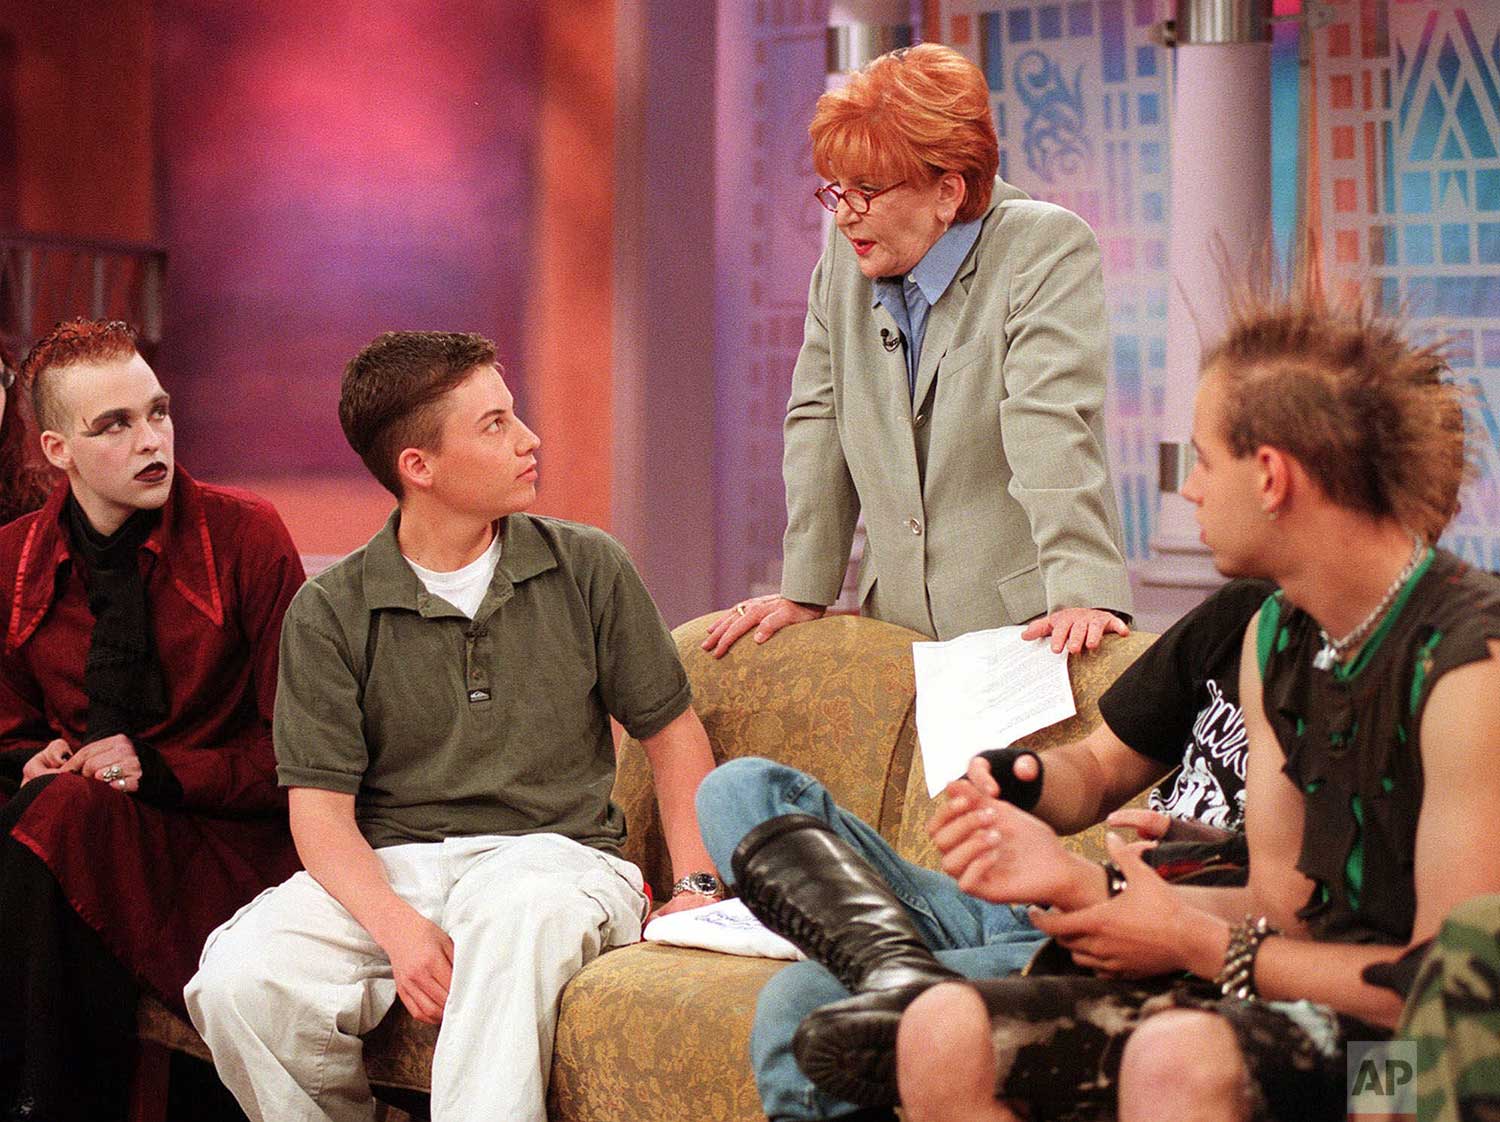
[1397, 896, 1500, 1122]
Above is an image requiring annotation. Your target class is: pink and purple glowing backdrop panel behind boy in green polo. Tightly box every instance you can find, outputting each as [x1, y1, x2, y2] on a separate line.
[156, 0, 543, 476]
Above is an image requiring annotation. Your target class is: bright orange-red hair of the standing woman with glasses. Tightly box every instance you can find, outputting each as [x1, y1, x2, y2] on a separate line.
[807, 44, 1001, 222]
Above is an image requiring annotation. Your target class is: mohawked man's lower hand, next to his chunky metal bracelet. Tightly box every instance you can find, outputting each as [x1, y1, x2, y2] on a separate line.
[1031, 834, 1229, 978]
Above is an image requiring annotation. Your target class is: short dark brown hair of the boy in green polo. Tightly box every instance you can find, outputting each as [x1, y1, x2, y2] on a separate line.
[339, 332, 498, 500]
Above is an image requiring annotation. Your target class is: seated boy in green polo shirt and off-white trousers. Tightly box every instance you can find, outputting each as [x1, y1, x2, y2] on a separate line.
[188, 332, 717, 1122]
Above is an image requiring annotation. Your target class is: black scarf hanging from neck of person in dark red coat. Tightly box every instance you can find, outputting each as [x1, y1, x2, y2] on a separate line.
[63, 494, 167, 744]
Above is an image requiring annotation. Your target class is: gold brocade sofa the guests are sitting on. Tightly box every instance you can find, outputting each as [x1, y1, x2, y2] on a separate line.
[141, 614, 1154, 1122]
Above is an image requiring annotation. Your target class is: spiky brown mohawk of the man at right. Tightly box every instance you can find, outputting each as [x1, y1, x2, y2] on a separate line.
[1203, 285, 1470, 543]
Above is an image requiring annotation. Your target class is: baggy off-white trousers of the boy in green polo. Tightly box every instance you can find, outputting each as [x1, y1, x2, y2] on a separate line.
[186, 834, 645, 1122]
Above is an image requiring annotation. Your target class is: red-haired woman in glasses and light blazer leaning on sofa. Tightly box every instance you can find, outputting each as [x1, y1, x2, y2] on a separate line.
[704, 44, 1131, 656]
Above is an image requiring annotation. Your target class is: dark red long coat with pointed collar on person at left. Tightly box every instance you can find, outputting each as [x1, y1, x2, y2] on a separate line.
[0, 468, 303, 1010]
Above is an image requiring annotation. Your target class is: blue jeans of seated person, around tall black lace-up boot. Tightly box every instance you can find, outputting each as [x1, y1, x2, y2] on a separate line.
[698, 759, 1043, 1119]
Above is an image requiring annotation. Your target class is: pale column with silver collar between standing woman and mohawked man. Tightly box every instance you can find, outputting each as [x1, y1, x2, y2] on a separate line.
[1140, 0, 1271, 590]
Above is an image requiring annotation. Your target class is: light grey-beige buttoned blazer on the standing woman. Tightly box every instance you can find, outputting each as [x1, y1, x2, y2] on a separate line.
[782, 179, 1131, 639]
